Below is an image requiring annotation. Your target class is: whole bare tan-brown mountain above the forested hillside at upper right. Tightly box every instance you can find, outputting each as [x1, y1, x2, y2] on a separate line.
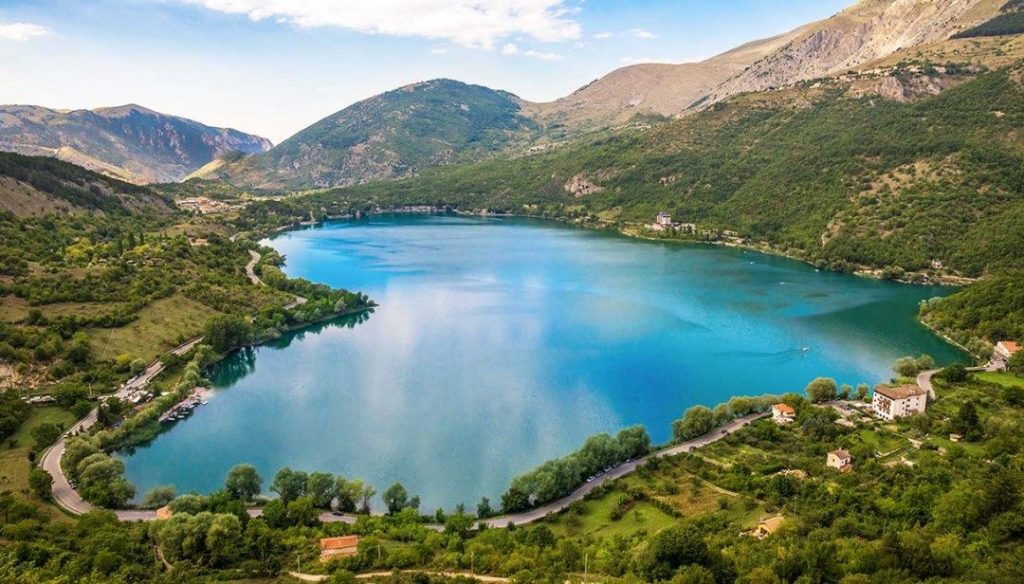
[527, 0, 1018, 126]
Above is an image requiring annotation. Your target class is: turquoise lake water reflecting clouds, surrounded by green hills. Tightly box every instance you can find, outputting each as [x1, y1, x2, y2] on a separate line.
[117, 216, 961, 511]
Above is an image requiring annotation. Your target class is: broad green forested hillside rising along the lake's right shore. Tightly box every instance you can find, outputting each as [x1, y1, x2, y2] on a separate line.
[321, 66, 1024, 277]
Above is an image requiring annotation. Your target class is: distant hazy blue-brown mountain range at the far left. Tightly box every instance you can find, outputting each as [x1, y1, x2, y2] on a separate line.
[0, 105, 271, 183]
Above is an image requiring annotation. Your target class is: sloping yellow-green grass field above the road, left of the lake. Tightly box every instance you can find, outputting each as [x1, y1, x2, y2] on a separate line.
[89, 295, 217, 363]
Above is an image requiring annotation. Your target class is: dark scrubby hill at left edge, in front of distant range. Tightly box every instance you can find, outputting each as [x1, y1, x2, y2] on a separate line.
[0, 153, 174, 217]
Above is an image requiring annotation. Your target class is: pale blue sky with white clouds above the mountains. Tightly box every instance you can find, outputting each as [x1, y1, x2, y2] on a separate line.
[0, 0, 852, 142]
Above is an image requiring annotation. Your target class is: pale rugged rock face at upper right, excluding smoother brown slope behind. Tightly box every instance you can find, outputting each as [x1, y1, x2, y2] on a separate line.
[709, 0, 1005, 101]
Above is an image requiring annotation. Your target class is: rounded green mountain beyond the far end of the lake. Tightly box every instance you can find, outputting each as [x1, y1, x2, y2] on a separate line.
[199, 79, 538, 189]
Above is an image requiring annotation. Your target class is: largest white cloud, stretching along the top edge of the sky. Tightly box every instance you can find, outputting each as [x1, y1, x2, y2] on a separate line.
[179, 0, 582, 50]
